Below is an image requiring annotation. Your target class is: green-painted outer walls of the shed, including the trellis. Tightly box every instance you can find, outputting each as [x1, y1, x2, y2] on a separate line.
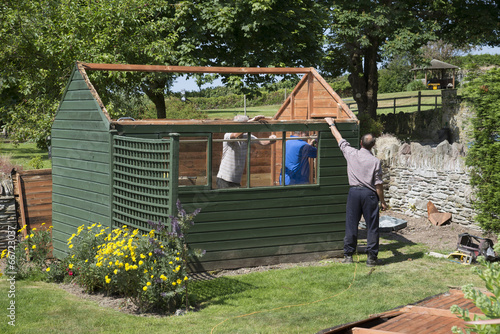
[52, 64, 359, 270]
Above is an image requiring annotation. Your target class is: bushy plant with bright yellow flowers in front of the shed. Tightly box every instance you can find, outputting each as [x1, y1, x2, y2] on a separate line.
[46, 201, 202, 312]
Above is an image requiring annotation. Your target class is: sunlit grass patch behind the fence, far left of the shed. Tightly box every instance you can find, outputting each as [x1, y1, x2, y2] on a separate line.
[0, 139, 52, 170]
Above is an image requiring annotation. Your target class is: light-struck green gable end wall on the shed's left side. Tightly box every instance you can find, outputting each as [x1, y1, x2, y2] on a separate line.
[51, 66, 111, 257]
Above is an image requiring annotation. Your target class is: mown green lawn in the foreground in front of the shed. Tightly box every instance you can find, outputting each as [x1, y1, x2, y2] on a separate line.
[0, 240, 484, 334]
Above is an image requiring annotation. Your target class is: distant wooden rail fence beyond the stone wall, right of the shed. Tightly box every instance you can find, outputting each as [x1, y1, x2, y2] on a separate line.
[344, 91, 441, 114]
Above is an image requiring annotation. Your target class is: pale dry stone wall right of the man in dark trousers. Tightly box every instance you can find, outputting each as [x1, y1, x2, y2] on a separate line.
[376, 137, 474, 227]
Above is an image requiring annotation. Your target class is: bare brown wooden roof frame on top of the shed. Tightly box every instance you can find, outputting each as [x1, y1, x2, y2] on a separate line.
[77, 62, 359, 125]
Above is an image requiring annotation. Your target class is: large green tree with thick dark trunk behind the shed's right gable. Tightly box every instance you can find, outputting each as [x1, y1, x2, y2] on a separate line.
[323, 0, 499, 118]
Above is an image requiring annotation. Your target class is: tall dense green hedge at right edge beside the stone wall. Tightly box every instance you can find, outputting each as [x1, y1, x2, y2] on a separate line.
[463, 68, 500, 232]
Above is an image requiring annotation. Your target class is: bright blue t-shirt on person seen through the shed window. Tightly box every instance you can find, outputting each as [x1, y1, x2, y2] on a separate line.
[280, 136, 318, 185]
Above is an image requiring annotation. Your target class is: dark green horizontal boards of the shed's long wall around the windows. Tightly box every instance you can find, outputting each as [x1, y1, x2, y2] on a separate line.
[114, 123, 359, 271]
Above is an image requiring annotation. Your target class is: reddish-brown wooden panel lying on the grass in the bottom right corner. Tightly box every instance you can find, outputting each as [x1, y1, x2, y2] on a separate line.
[318, 289, 483, 334]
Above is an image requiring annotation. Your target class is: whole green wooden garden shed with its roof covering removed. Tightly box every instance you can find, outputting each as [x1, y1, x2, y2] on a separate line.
[51, 62, 359, 271]
